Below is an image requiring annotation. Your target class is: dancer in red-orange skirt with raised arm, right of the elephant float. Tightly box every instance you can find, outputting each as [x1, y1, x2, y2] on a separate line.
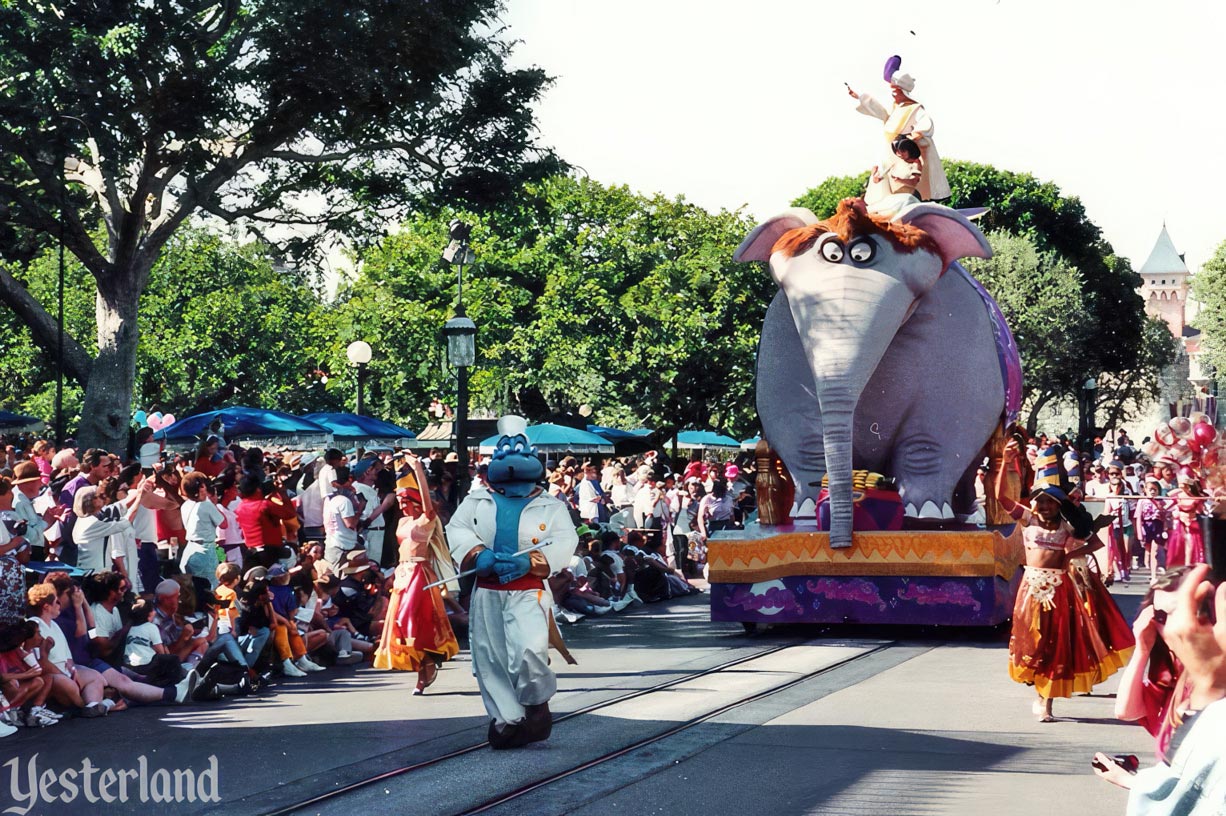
[996, 441, 1130, 723]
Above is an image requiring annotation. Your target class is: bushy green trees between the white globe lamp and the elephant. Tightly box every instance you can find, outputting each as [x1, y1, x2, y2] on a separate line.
[333, 176, 774, 433]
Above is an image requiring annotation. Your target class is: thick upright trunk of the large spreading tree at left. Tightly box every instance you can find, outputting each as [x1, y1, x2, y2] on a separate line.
[77, 268, 143, 455]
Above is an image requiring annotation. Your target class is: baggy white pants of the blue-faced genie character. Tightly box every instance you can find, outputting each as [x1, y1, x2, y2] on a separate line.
[468, 587, 558, 727]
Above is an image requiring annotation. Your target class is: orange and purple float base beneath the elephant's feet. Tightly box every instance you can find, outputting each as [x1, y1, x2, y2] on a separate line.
[707, 523, 1022, 626]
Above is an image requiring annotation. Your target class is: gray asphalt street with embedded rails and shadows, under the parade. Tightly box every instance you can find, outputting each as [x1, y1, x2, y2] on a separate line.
[0, 580, 1151, 816]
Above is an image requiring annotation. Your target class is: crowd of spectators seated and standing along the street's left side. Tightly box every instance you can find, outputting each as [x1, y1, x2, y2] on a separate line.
[0, 436, 753, 735]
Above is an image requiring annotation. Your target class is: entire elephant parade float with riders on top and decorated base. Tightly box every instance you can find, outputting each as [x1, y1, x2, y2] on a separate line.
[707, 56, 1022, 626]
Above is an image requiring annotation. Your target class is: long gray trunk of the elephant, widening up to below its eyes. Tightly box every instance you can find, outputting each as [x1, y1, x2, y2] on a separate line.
[788, 272, 915, 546]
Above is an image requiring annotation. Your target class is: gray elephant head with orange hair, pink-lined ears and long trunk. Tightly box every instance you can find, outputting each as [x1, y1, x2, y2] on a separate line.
[733, 198, 991, 546]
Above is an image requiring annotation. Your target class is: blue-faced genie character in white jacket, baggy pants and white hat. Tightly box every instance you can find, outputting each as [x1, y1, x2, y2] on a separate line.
[447, 417, 579, 749]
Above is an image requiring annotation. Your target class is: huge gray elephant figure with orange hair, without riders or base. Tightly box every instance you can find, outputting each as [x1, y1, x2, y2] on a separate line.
[734, 198, 1021, 548]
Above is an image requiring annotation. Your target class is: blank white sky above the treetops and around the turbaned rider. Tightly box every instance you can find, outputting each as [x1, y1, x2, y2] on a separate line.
[505, 0, 1226, 272]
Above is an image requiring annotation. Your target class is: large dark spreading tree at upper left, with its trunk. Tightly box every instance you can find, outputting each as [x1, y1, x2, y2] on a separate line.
[0, 0, 558, 446]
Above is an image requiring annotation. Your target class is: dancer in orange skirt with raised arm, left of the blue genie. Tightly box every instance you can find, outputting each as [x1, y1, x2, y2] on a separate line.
[374, 457, 460, 695]
